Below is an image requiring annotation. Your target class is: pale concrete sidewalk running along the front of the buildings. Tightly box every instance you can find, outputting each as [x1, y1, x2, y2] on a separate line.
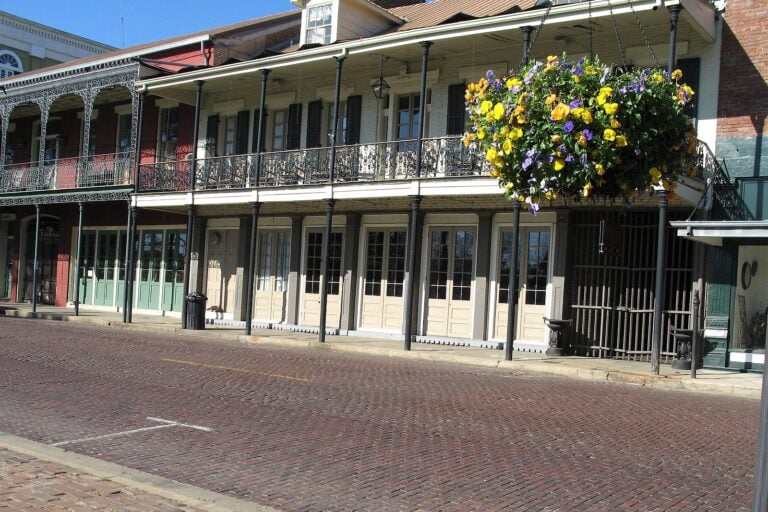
[4, 304, 762, 399]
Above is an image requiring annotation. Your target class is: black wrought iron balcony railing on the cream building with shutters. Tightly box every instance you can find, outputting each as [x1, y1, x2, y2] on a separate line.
[138, 137, 487, 192]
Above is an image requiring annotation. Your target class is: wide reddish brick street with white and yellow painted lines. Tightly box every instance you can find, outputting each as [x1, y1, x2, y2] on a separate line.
[0, 318, 759, 512]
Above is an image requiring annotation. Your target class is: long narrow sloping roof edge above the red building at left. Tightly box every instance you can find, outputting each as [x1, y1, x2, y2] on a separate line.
[0, 9, 301, 83]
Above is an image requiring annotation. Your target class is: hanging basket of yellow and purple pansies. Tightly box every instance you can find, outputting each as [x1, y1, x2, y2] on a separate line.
[464, 55, 697, 213]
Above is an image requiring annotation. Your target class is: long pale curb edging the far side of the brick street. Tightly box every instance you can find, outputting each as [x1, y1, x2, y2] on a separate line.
[5, 310, 761, 399]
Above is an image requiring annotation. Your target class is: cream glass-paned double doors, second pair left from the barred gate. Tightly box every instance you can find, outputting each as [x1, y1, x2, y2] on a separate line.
[426, 228, 475, 338]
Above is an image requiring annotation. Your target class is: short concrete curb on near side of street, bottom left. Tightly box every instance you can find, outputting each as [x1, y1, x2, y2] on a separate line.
[0, 432, 279, 512]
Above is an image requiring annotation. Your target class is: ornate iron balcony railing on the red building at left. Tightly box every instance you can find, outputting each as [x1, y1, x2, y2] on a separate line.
[0, 153, 133, 193]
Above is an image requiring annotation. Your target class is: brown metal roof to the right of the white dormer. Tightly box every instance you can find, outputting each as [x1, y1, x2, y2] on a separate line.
[389, 0, 538, 31]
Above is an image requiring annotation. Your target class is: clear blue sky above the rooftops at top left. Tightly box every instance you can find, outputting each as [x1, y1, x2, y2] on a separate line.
[5, 0, 296, 48]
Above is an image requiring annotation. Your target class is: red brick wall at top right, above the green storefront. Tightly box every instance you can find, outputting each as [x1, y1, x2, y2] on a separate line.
[717, 0, 768, 138]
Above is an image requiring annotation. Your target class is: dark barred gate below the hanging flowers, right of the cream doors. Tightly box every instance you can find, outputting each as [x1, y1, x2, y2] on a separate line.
[567, 211, 694, 361]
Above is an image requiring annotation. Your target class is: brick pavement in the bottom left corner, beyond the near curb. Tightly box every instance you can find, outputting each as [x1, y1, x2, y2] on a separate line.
[0, 449, 200, 512]
